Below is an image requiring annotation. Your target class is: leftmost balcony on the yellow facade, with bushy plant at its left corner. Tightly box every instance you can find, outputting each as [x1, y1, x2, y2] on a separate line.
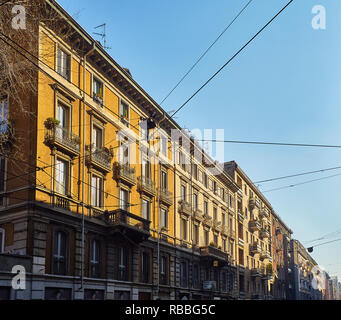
[44, 126, 80, 155]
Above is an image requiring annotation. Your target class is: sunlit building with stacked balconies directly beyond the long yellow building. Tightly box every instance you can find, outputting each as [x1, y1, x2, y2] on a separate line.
[224, 161, 274, 299]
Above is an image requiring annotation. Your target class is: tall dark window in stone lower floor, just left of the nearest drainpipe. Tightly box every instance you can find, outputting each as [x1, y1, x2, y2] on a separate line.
[53, 231, 67, 275]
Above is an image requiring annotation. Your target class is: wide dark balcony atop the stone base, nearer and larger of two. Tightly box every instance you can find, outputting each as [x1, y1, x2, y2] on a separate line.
[105, 209, 150, 243]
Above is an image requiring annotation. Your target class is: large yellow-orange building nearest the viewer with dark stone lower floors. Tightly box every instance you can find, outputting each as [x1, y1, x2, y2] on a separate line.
[0, 0, 239, 300]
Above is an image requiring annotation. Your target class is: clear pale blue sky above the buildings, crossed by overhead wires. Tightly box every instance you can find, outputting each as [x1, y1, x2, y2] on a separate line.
[59, 0, 341, 278]
